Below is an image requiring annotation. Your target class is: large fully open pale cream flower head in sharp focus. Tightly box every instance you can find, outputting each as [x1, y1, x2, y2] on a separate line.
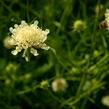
[9, 21, 49, 61]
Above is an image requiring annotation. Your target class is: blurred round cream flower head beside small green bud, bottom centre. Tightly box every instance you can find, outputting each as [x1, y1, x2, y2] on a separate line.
[52, 78, 68, 92]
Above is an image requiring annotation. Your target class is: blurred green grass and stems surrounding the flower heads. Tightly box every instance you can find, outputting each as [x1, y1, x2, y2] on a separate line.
[0, 0, 109, 109]
